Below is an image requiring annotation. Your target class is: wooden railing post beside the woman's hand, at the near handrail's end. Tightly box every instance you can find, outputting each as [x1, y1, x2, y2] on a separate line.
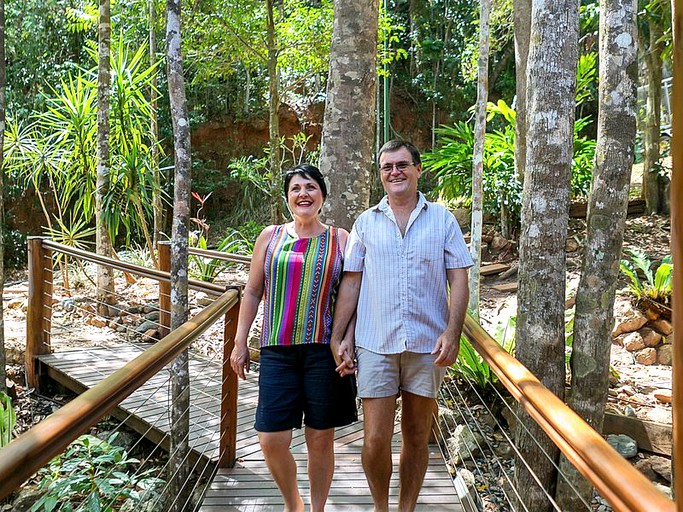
[218, 290, 242, 468]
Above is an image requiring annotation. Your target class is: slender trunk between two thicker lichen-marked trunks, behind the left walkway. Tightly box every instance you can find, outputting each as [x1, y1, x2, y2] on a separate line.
[150, 0, 164, 252]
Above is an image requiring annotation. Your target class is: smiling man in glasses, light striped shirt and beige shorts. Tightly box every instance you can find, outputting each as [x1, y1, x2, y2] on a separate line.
[331, 140, 472, 512]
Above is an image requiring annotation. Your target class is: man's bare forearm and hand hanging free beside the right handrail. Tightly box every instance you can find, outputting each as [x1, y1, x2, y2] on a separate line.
[432, 268, 469, 367]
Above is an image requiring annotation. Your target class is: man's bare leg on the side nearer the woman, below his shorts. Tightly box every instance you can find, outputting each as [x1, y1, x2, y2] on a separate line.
[362, 396, 396, 512]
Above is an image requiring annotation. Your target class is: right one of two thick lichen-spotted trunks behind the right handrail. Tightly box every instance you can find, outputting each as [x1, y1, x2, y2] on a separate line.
[557, 0, 638, 510]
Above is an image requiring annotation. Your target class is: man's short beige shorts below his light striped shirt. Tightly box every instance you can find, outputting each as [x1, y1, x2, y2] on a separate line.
[356, 347, 447, 398]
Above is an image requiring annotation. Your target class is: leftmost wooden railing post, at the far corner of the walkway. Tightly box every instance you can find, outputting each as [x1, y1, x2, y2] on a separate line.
[24, 237, 52, 388]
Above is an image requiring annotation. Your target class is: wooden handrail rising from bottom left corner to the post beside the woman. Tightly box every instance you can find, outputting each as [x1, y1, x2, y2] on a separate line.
[0, 290, 239, 500]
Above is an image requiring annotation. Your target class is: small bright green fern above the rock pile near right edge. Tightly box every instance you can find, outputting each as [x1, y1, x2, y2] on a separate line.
[619, 249, 673, 304]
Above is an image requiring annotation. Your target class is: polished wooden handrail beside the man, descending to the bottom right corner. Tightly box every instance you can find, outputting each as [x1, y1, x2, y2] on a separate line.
[463, 316, 675, 512]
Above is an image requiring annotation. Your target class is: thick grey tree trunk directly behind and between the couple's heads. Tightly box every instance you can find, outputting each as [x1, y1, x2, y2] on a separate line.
[320, 0, 379, 229]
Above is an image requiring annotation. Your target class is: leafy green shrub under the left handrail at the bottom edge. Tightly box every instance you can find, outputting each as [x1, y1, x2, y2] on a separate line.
[31, 434, 164, 512]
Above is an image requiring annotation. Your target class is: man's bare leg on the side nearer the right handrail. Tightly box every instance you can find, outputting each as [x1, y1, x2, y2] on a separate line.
[398, 391, 434, 512]
